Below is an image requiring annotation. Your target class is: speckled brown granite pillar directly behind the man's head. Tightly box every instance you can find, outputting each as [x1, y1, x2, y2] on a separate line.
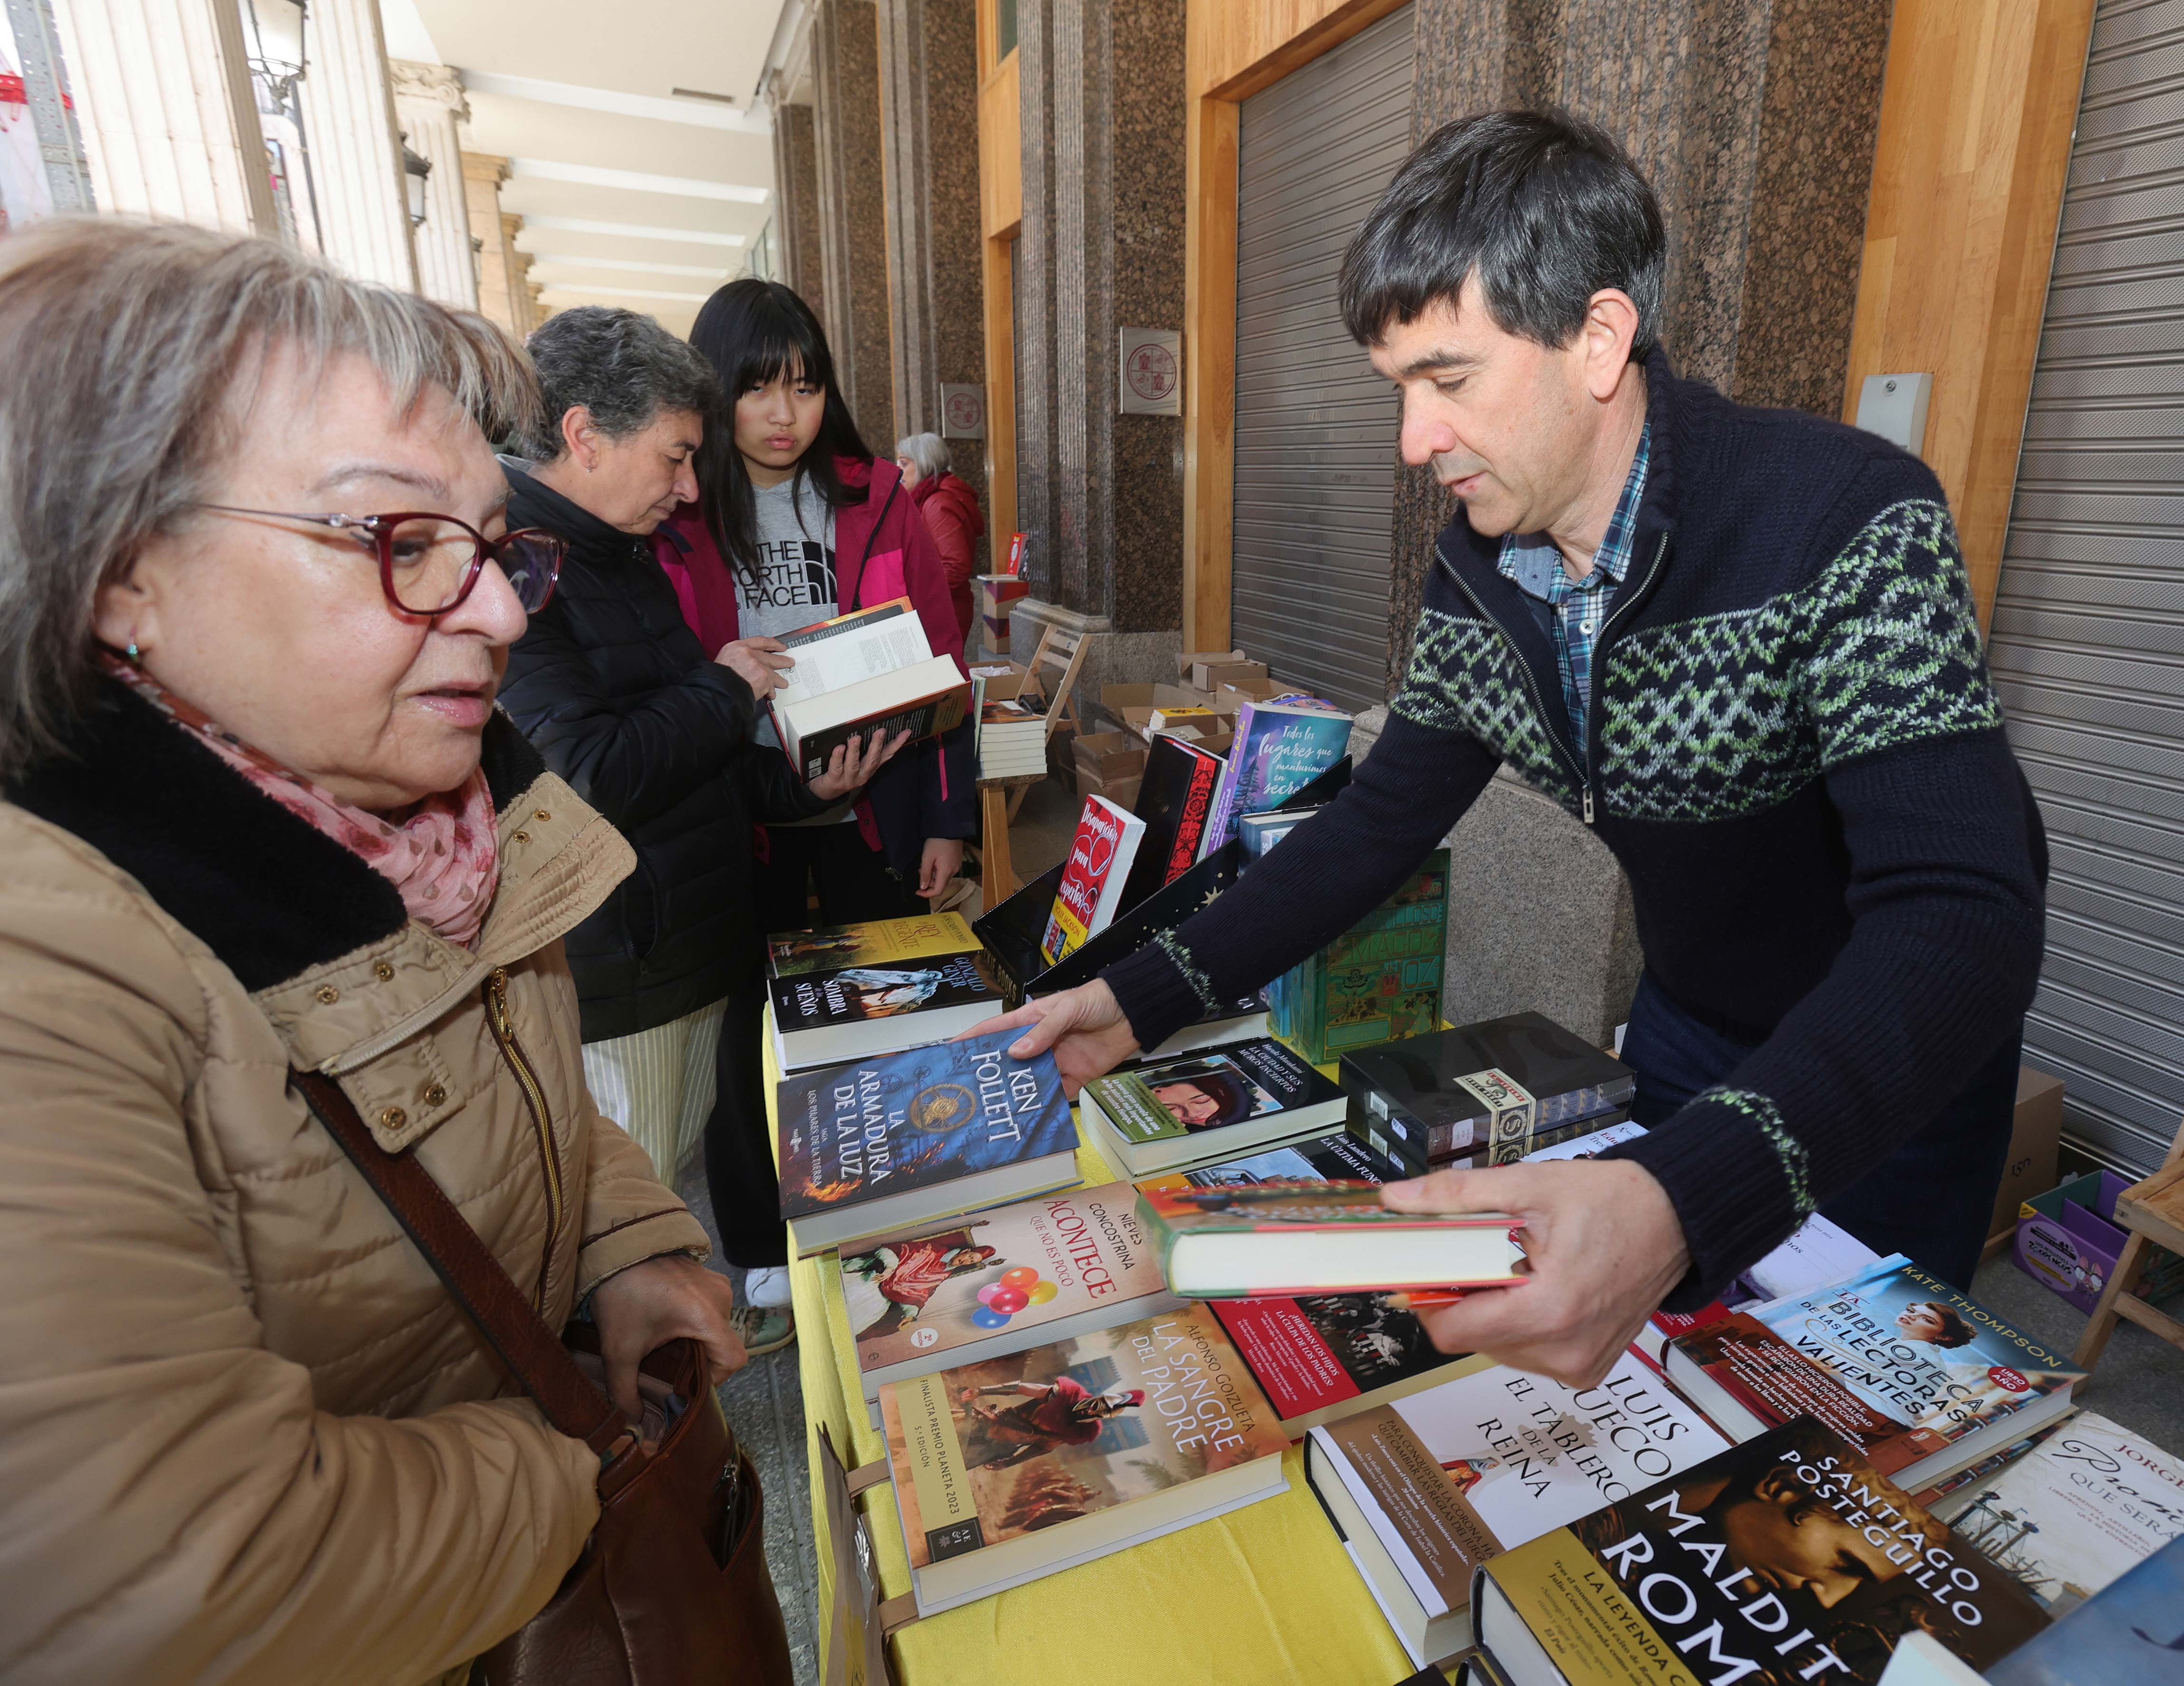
[1389, 0, 1889, 679]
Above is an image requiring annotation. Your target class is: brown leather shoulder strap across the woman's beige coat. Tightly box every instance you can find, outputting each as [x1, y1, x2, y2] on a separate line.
[288, 1070, 633, 1457]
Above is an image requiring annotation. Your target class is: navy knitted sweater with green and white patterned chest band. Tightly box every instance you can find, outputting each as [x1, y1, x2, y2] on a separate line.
[1105, 352, 2047, 1306]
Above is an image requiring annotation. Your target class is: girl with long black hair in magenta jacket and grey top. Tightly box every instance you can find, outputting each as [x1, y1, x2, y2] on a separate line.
[653, 279, 976, 1306]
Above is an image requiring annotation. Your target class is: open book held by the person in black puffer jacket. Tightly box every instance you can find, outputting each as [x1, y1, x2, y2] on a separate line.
[766, 596, 970, 782]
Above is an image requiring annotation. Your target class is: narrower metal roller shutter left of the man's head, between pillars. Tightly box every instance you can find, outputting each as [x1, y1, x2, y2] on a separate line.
[1229, 7, 1415, 708]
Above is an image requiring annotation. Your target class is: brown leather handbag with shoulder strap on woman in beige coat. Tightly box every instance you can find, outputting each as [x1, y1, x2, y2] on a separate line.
[290, 1070, 791, 1686]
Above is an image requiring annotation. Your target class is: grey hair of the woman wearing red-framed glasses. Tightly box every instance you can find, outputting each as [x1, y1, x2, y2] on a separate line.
[0, 216, 537, 778]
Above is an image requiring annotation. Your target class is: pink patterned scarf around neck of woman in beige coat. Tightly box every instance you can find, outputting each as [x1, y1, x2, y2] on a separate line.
[100, 655, 500, 948]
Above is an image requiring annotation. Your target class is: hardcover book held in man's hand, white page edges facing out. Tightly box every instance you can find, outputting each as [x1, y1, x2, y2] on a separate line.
[1138, 1179, 1525, 1300]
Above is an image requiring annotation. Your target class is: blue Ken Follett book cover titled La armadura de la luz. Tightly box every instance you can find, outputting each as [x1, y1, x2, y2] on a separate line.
[780, 1031, 1077, 1219]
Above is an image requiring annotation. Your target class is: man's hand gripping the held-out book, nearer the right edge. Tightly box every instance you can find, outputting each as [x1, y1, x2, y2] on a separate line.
[1380, 1162, 1691, 1387]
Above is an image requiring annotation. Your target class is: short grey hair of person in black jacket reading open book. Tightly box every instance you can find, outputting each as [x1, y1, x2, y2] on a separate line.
[526, 304, 721, 463]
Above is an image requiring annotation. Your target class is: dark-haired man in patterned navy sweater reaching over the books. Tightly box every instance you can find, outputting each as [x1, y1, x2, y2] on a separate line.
[991, 111, 2047, 1382]
